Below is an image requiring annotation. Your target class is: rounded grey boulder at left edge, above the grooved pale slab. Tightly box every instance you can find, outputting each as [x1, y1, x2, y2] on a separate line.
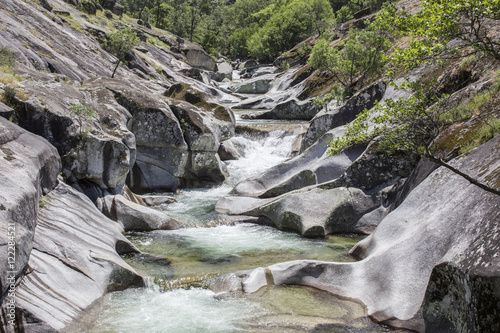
[0, 117, 61, 296]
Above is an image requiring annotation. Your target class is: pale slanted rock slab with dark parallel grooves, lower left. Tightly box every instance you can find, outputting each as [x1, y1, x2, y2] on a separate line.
[3, 183, 144, 332]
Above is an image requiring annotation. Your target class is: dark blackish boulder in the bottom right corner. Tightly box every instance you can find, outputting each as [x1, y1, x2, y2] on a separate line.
[422, 260, 500, 332]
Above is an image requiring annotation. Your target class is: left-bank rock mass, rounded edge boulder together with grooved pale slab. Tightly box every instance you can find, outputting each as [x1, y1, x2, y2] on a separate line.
[0, 118, 143, 332]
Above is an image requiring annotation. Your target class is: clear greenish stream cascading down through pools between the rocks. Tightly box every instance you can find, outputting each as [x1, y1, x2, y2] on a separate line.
[68, 118, 390, 333]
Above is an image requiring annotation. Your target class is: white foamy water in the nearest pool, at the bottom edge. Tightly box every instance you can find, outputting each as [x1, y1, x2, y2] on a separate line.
[87, 289, 264, 333]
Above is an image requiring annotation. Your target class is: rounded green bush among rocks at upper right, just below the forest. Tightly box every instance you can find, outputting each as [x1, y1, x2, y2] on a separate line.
[309, 29, 390, 97]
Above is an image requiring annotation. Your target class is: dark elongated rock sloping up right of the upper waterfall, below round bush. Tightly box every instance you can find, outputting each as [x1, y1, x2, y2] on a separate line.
[301, 82, 386, 151]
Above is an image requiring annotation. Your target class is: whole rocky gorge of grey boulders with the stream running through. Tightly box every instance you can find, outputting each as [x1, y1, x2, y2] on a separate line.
[0, 0, 500, 332]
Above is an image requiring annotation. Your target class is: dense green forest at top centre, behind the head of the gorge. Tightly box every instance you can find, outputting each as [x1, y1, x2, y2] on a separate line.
[114, 0, 394, 60]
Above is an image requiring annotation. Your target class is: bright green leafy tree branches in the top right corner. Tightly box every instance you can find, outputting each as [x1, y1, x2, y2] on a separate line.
[376, 0, 500, 69]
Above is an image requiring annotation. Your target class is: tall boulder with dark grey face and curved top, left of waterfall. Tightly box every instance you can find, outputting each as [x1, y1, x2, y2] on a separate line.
[93, 78, 194, 193]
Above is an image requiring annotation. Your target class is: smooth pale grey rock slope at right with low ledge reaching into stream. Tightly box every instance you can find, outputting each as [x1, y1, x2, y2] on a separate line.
[213, 136, 500, 331]
